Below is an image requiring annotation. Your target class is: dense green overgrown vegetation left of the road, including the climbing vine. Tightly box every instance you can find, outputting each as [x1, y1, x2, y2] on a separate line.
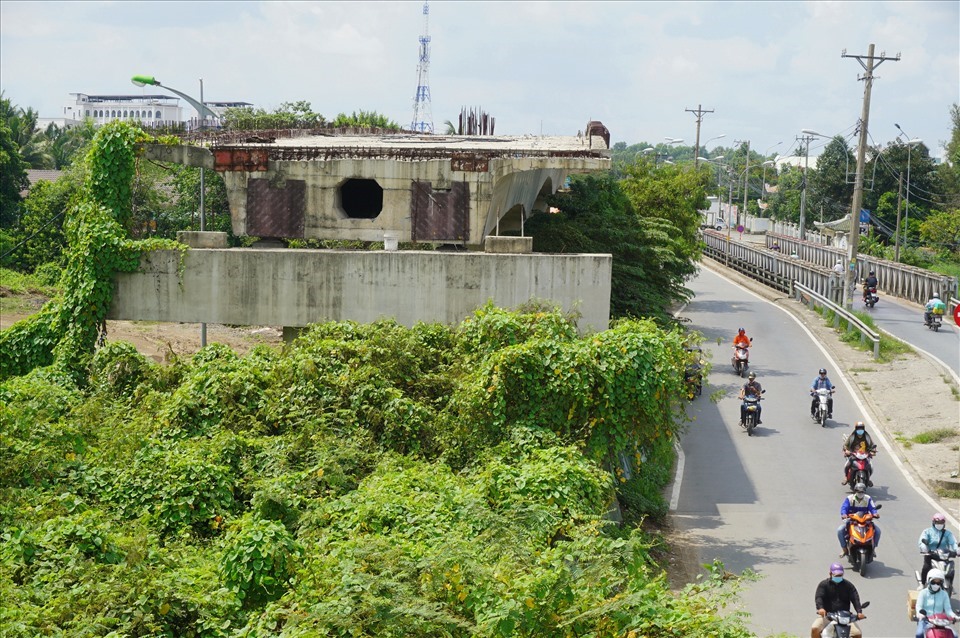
[0, 119, 748, 638]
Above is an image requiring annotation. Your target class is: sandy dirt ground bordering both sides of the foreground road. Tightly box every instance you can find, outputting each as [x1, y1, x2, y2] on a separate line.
[668, 259, 960, 587]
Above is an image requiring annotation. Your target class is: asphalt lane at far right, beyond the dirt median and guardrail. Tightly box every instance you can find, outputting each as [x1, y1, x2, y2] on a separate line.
[853, 288, 960, 382]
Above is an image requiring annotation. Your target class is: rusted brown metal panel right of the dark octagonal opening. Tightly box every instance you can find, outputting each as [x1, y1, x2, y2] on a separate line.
[410, 181, 470, 242]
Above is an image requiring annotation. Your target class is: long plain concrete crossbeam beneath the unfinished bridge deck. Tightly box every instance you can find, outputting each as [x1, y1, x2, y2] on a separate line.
[108, 248, 612, 331]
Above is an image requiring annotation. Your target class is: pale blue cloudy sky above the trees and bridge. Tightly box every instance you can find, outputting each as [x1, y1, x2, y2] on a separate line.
[0, 0, 960, 156]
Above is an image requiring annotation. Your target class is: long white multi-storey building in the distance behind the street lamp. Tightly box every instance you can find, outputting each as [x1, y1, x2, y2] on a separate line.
[62, 93, 183, 126]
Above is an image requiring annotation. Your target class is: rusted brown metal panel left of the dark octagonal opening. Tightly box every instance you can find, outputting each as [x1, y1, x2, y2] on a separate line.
[247, 179, 307, 239]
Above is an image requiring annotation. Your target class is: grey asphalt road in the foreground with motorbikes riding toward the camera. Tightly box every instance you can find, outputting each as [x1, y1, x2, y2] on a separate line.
[671, 269, 956, 638]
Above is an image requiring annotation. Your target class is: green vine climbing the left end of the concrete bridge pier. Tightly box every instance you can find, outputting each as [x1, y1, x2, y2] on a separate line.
[0, 121, 185, 384]
